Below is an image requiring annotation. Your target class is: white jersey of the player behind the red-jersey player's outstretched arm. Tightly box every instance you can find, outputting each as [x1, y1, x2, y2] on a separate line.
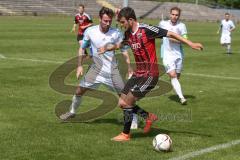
[159, 20, 187, 59]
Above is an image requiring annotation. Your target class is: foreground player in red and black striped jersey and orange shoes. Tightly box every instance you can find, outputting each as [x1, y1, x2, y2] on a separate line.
[98, 7, 203, 141]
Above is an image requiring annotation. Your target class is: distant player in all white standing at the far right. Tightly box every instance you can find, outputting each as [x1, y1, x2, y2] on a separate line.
[217, 13, 235, 54]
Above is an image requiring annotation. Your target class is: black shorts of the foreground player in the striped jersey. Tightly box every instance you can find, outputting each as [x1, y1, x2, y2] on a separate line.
[122, 75, 158, 98]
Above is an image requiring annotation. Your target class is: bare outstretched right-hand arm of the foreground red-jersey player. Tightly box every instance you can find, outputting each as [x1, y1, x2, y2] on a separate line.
[167, 31, 203, 50]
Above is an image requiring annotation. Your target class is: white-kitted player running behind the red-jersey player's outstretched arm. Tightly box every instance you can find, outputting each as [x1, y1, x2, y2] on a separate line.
[159, 7, 187, 105]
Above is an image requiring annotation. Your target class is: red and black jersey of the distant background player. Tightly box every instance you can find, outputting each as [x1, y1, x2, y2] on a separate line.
[74, 13, 92, 35]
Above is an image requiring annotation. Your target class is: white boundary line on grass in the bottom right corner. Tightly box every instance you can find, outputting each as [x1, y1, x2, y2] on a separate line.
[168, 139, 240, 160]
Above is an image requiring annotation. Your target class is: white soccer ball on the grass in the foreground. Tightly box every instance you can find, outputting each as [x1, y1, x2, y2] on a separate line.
[153, 134, 172, 151]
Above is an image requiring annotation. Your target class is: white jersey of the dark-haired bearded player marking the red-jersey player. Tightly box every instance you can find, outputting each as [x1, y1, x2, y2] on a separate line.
[83, 25, 123, 74]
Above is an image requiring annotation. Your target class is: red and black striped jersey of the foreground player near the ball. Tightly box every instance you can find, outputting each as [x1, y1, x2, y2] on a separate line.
[124, 24, 168, 77]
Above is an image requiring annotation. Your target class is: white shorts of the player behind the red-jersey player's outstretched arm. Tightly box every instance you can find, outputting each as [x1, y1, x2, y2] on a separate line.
[163, 58, 183, 73]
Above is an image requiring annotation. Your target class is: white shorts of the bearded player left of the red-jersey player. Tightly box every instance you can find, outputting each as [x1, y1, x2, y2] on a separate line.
[80, 66, 124, 94]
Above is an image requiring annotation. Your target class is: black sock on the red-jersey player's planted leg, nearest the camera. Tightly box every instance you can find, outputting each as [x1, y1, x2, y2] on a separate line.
[123, 108, 133, 134]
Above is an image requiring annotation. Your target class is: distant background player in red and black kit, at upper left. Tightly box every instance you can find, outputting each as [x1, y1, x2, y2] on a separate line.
[71, 4, 93, 55]
